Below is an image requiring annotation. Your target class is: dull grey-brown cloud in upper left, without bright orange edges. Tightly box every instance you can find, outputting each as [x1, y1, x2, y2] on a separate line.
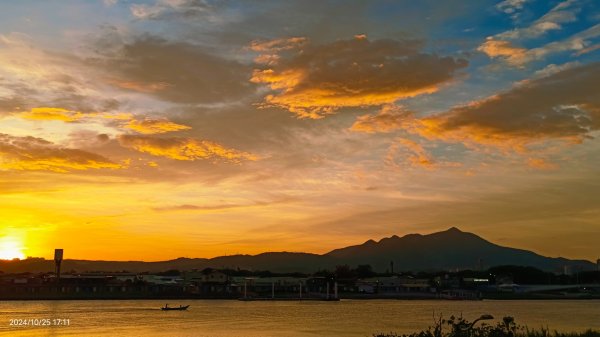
[95, 36, 253, 103]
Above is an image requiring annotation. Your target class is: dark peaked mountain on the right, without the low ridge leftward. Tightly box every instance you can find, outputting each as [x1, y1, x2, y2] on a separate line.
[325, 227, 595, 271]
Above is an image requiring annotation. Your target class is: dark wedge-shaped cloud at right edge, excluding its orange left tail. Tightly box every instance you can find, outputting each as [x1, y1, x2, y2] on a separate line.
[425, 63, 600, 146]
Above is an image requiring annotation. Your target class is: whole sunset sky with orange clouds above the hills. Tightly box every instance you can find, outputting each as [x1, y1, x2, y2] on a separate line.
[0, 0, 600, 261]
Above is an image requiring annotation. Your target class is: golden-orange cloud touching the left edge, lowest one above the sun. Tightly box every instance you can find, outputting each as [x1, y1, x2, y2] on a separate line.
[0, 134, 125, 173]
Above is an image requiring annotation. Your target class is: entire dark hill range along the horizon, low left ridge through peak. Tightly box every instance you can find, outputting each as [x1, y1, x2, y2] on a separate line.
[0, 227, 596, 273]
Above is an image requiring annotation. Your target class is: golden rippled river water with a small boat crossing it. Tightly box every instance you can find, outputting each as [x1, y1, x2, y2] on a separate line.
[0, 300, 600, 337]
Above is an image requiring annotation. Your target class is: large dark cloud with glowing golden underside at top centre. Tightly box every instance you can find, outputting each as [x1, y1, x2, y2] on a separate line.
[250, 35, 467, 119]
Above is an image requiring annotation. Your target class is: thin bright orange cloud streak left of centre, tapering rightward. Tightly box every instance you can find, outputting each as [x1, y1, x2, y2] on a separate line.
[119, 135, 258, 162]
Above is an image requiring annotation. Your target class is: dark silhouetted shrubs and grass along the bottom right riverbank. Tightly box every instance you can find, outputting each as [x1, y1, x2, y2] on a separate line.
[373, 315, 600, 337]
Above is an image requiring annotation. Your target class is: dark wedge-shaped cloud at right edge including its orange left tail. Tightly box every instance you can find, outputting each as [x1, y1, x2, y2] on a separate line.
[352, 63, 600, 149]
